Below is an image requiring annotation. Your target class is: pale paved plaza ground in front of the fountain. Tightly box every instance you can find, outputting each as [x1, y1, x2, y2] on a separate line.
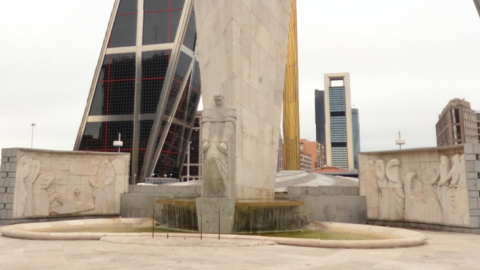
[0, 231, 480, 270]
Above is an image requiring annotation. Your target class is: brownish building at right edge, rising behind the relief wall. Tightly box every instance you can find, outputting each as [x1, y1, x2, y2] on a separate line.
[435, 98, 480, 146]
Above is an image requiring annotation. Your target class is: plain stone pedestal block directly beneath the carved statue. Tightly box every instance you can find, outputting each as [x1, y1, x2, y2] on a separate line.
[196, 198, 235, 234]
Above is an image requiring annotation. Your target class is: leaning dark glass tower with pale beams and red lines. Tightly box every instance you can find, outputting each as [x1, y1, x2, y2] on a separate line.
[75, 0, 200, 184]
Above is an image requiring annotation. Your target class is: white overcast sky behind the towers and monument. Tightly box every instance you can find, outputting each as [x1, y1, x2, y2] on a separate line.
[0, 0, 480, 151]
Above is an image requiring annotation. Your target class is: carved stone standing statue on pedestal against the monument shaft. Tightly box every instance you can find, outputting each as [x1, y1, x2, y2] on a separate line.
[202, 95, 237, 198]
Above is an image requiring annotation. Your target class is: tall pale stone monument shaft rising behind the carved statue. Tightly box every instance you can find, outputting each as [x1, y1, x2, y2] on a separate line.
[195, 0, 291, 199]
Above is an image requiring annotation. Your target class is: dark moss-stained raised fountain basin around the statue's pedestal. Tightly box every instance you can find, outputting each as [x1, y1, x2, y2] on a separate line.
[155, 198, 307, 233]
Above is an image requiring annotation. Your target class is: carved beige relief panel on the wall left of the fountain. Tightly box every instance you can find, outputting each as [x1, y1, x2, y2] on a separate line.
[13, 150, 129, 218]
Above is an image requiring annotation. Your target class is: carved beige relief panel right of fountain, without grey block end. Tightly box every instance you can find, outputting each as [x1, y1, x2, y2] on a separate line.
[359, 152, 470, 226]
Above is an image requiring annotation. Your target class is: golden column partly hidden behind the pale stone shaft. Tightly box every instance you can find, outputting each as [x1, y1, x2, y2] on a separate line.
[283, 0, 300, 170]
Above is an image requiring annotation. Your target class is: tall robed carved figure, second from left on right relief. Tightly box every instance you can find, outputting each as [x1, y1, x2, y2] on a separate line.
[385, 159, 405, 220]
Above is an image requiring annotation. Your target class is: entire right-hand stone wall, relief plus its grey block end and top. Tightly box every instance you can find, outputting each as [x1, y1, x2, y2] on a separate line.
[359, 144, 480, 229]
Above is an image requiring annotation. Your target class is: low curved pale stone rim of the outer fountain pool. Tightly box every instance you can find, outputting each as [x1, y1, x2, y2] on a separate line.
[1, 218, 426, 248]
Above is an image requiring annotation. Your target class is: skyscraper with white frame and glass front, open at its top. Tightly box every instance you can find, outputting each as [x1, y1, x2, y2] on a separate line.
[324, 73, 358, 170]
